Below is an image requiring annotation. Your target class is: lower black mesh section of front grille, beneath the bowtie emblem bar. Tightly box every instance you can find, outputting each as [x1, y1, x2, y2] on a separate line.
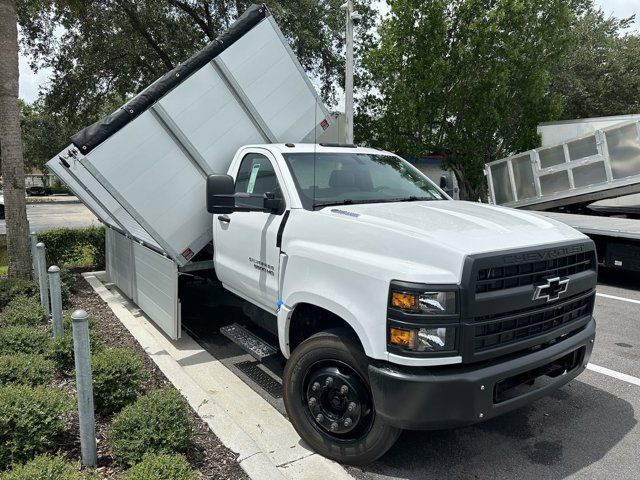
[472, 293, 595, 353]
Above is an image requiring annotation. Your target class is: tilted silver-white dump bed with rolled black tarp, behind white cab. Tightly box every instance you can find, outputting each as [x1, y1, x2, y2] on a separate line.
[47, 5, 333, 267]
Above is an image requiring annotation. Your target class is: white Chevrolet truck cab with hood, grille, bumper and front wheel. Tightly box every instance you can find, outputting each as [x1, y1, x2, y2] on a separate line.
[207, 144, 597, 464]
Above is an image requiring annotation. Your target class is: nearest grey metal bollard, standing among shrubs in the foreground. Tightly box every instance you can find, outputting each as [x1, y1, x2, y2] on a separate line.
[71, 310, 97, 467]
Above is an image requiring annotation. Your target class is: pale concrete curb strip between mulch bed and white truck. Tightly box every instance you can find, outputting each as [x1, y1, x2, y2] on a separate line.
[83, 272, 353, 480]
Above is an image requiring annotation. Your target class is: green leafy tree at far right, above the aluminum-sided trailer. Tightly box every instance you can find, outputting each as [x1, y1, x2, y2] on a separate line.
[551, 9, 640, 119]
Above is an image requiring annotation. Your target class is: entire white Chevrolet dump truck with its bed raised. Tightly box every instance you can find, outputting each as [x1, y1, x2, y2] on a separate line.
[48, 6, 597, 464]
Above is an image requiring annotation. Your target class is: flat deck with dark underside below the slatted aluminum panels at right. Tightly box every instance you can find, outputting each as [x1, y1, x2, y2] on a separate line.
[536, 212, 640, 272]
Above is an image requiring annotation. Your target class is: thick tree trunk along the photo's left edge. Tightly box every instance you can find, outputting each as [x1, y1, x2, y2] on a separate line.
[0, 0, 31, 278]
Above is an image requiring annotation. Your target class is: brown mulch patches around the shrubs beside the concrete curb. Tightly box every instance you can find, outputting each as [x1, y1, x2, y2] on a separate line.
[60, 275, 248, 479]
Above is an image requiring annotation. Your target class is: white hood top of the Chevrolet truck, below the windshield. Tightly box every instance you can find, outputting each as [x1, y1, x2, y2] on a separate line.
[323, 201, 585, 254]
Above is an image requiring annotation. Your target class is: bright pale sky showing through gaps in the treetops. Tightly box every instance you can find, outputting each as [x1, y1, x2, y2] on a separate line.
[20, 0, 640, 102]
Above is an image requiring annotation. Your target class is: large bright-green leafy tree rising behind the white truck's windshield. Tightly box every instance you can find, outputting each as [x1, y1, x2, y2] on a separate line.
[357, 0, 589, 200]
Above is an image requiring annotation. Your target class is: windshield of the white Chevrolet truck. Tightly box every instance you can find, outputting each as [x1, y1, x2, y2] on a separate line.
[283, 153, 446, 210]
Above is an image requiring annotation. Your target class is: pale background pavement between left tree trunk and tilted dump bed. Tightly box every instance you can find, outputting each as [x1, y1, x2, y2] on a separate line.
[0, 203, 101, 234]
